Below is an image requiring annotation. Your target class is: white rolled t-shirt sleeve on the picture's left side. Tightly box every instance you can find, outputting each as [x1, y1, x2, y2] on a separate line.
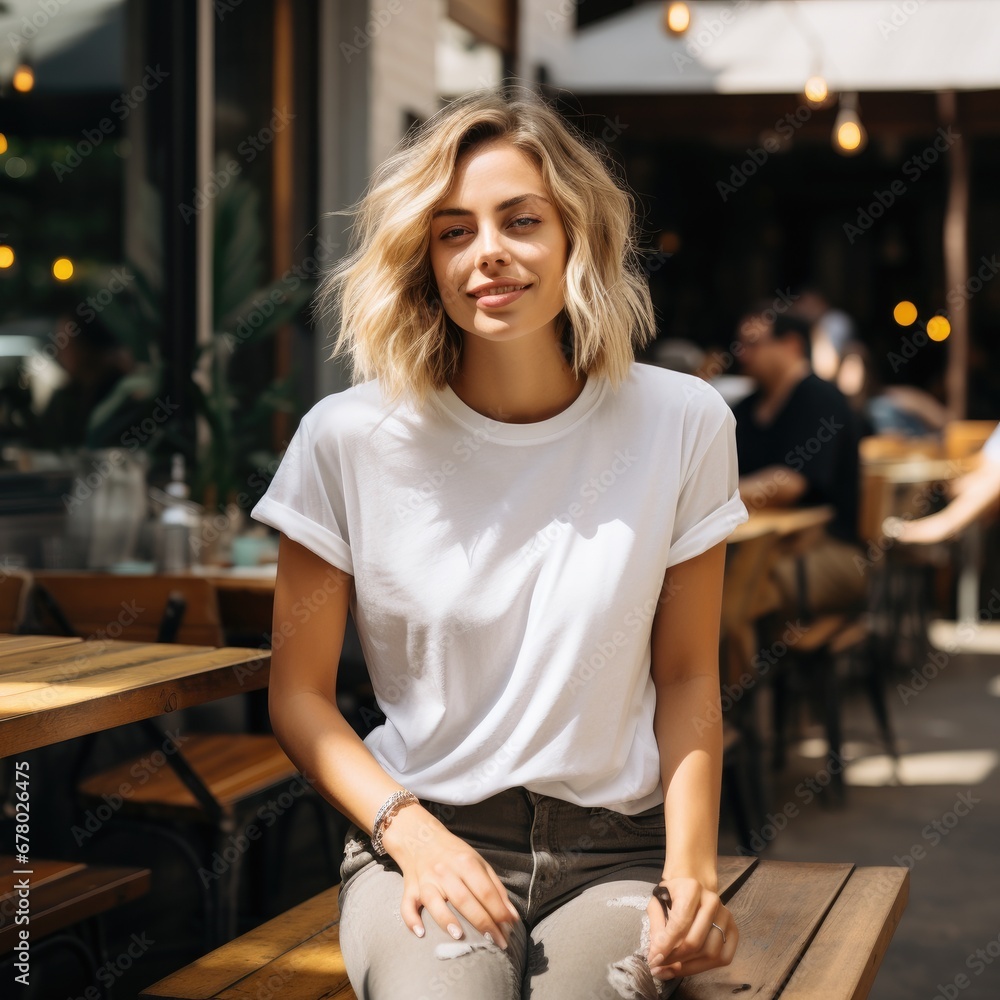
[250, 410, 354, 576]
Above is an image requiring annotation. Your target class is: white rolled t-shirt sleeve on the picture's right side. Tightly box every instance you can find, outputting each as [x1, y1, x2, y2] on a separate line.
[667, 401, 748, 566]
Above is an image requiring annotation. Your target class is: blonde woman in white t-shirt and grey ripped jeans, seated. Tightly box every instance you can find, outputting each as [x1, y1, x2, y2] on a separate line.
[254, 92, 746, 1000]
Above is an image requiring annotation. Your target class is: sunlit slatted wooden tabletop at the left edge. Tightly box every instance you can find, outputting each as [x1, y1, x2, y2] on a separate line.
[0, 635, 271, 757]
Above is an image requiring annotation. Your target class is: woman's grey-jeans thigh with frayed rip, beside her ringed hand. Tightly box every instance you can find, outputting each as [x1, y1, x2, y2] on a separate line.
[523, 868, 677, 1000]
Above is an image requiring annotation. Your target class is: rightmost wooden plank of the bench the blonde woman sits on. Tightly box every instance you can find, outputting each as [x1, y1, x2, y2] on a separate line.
[781, 868, 910, 1000]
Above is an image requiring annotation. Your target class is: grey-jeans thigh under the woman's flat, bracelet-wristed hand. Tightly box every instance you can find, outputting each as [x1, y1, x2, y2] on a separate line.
[340, 844, 527, 1000]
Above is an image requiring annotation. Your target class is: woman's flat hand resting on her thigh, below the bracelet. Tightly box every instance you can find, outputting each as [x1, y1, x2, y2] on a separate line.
[383, 803, 520, 948]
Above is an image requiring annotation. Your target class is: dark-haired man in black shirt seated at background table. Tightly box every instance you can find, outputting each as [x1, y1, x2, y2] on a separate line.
[733, 309, 866, 614]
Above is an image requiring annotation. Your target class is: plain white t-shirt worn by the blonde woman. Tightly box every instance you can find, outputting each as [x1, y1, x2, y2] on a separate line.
[253, 364, 747, 814]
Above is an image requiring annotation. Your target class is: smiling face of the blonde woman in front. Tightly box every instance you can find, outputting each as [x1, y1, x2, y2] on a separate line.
[430, 143, 569, 341]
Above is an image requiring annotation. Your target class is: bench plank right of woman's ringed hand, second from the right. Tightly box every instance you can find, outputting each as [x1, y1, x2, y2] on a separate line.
[674, 861, 854, 1000]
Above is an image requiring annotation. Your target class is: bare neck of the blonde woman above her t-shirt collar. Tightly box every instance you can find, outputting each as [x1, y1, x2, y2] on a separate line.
[451, 335, 586, 424]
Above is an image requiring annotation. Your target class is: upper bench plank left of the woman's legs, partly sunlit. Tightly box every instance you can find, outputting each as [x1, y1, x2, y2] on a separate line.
[141, 885, 340, 1000]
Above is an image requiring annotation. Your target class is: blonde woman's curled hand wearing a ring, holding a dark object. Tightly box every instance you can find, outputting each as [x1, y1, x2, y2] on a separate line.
[646, 878, 740, 979]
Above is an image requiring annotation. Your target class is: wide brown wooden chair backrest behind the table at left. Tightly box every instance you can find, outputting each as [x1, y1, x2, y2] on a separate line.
[35, 572, 225, 646]
